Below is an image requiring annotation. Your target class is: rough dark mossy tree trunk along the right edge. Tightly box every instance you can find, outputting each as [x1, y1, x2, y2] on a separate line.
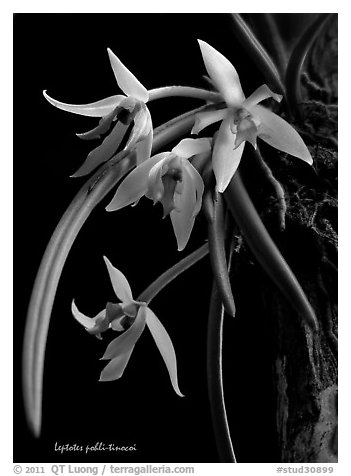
[234, 18, 337, 463]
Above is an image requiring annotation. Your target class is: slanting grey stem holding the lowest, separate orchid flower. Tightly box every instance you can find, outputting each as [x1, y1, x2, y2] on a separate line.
[138, 243, 209, 304]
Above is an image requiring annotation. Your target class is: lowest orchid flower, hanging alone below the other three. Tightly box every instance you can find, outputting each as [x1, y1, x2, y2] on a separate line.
[72, 257, 184, 397]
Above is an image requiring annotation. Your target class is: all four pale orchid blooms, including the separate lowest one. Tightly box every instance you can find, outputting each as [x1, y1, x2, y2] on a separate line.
[44, 40, 312, 396]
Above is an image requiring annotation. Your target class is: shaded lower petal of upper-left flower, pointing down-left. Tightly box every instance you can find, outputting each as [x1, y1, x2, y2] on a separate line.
[71, 121, 128, 177]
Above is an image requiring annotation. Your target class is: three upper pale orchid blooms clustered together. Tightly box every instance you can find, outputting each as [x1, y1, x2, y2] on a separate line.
[44, 40, 312, 250]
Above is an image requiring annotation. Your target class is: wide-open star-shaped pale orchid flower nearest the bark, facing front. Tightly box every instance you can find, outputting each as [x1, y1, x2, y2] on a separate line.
[192, 40, 312, 192]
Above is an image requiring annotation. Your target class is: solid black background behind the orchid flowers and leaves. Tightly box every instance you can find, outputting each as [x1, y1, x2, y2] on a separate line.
[14, 14, 275, 463]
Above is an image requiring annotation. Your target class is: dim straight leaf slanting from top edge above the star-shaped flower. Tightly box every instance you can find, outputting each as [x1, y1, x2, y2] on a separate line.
[230, 13, 285, 95]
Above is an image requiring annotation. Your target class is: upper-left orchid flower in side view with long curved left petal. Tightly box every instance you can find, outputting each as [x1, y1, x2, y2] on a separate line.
[43, 48, 153, 177]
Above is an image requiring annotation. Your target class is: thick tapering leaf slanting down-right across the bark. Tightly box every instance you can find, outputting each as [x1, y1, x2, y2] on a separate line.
[224, 170, 318, 330]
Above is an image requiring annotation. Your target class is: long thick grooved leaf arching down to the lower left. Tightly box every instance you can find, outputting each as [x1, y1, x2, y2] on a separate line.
[23, 108, 206, 436]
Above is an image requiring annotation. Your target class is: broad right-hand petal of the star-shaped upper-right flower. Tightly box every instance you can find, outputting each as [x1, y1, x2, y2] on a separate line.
[249, 105, 313, 165]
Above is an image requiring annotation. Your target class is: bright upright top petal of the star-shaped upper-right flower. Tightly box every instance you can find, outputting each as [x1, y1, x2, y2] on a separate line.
[198, 40, 245, 106]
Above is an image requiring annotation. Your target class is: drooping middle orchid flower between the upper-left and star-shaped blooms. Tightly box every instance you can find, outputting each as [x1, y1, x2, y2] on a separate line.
[106, 138, 211, 251]
